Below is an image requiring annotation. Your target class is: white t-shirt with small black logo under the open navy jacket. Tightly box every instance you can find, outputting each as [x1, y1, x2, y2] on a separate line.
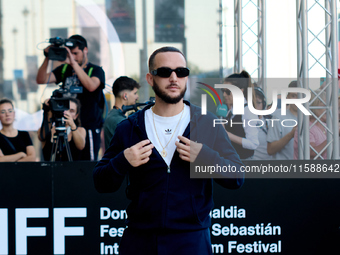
[145, 105, 190, 166]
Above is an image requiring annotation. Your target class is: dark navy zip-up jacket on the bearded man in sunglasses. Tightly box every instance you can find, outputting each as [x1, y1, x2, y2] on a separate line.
[93, 101, 244, 231]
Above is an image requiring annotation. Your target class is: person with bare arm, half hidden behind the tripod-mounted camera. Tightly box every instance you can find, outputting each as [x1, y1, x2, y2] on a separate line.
[38, 98, 86, 161]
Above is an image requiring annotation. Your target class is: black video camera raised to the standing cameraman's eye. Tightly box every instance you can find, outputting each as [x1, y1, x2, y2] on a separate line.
[48, 37, 75, 61]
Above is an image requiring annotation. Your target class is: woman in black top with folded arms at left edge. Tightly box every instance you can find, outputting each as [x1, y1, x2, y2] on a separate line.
[0, 99, 36, 162]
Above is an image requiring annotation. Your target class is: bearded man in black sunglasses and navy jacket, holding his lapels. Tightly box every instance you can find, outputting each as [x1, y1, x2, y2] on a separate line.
[93, 47, 244, 255]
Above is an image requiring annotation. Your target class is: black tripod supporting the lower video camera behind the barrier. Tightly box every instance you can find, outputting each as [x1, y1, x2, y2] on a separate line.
[51, 126, 73, 162]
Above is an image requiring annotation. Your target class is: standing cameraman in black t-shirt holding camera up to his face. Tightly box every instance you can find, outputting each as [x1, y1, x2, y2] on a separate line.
[37, 35, 105, 161]
